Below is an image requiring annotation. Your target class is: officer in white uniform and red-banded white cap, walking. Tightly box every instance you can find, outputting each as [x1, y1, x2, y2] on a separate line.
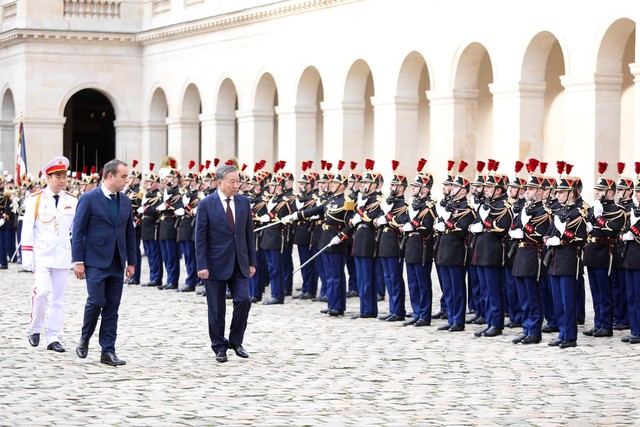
[21, 156, 78, 353]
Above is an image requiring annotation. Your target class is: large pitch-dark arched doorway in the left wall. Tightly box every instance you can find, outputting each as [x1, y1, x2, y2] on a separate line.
[63, 89, 116, 171]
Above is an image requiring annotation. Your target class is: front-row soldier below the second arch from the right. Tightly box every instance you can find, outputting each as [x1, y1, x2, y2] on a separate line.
[509, 169, 551, 344]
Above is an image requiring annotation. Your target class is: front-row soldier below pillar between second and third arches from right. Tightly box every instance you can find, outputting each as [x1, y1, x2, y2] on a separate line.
[469, 159, 513, 337]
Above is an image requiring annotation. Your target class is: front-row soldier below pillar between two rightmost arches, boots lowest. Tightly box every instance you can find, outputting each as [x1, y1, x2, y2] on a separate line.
[544, 169, 587, 348]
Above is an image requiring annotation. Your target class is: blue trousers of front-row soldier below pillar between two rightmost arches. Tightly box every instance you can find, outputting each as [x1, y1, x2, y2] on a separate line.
[548, 276, 578, 340]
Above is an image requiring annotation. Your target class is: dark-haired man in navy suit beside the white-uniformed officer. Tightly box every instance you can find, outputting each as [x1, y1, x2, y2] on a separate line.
[72, 160, 136, 366]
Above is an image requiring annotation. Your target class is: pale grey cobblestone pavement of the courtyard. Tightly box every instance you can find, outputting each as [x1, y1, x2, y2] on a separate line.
[0, 264, 640, 426]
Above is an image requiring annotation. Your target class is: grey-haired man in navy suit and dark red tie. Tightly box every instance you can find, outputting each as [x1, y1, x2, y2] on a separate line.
[195, 165, 256, 362]
